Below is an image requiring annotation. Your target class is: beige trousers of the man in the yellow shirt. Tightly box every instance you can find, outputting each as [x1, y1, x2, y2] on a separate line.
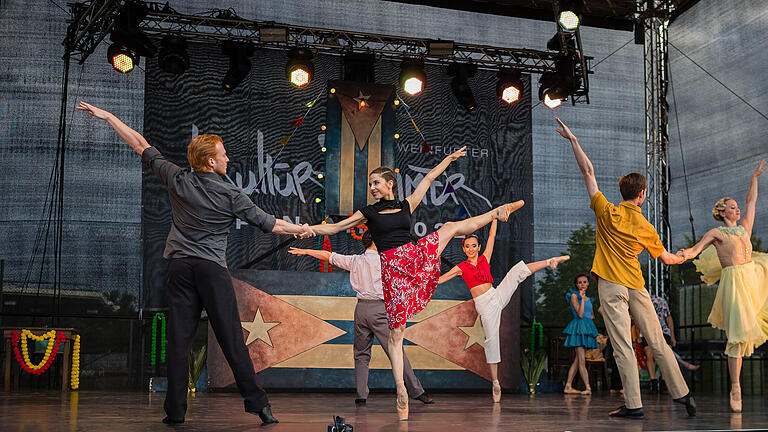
[597, 279, 688, 409]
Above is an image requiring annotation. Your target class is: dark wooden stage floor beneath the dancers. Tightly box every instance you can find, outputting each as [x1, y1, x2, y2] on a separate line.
[0, 391, 768, 432]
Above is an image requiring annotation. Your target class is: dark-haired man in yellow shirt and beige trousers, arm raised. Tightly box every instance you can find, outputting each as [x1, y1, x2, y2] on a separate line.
[556, 118, 696, 417]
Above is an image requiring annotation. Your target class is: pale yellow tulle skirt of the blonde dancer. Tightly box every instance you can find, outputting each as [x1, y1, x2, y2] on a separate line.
[693, 246, 768, 357]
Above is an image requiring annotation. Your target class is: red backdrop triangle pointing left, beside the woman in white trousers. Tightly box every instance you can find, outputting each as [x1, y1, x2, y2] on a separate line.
[405, 300, 491, 381]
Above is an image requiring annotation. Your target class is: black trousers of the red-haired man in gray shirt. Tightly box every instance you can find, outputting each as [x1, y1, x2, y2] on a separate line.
[163, 258, 268, 420]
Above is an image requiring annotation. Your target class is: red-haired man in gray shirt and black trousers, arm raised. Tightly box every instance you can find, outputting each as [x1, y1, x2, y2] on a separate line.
[77, 102, 314, 424]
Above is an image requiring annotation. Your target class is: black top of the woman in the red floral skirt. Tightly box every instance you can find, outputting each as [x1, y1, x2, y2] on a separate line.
[360, 200, 414, 252]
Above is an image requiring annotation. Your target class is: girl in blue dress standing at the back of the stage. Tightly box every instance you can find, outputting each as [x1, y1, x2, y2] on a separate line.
[563, 273, 599, 394]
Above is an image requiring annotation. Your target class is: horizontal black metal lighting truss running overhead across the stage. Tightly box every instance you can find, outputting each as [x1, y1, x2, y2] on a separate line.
[68, 0, 592, 103]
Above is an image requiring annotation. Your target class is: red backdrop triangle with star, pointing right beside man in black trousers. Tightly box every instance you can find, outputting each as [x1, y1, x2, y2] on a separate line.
[207, 278, 346, 388]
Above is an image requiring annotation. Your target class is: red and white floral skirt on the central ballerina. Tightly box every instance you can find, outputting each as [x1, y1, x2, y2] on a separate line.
[379, 231, 440, 329]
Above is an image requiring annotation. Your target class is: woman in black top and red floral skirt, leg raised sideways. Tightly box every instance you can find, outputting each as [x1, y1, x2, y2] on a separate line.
[304, 147, 523, 420]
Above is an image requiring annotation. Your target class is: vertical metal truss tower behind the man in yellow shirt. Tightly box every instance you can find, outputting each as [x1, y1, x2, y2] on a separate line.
[636, 0, 674, 296]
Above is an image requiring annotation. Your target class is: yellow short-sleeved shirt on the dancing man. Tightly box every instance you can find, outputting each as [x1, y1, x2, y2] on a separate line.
[589, 191, 664, 290]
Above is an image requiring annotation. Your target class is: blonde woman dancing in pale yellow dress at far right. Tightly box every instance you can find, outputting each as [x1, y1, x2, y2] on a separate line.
[678, 160, 768, 412]
